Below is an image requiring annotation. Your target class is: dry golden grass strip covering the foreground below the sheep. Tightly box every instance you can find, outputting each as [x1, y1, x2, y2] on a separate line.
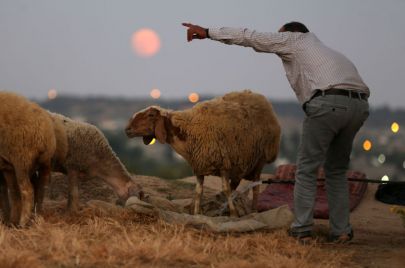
[0, 204, 352, 268]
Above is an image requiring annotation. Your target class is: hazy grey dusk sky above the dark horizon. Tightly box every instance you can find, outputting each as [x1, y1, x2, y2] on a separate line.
[0, 0, 405, 108]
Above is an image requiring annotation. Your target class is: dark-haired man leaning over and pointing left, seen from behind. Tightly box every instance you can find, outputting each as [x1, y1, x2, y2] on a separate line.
[183, 22, 370, 243]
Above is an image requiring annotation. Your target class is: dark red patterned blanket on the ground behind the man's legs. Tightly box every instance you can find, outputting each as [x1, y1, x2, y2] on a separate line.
[258, 164, 367, 219]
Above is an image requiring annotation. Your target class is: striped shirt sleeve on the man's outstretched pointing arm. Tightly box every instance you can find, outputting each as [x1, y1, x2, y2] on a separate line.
[208, 27, 297, 58]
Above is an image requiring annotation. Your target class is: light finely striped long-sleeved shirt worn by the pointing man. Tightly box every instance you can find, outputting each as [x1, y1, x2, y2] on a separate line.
[209, 27, 370, 104]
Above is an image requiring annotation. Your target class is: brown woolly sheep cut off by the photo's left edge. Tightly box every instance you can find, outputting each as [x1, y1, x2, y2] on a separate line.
[0, 92, 56, 226]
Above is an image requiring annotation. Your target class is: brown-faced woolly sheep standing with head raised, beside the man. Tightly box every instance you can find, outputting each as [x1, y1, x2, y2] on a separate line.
[125, 90, 281, 216]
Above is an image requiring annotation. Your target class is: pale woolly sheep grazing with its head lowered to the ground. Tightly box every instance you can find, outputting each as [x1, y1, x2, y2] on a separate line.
[50, 113, 143, 211]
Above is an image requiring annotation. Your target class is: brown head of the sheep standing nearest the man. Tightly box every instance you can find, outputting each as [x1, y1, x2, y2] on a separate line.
[125, 106, 167, 144]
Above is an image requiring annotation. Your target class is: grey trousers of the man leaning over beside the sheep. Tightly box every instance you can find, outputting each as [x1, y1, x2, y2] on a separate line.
[291, 95, 369, 235]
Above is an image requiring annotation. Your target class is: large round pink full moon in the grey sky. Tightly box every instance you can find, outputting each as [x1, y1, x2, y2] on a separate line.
[131, 28, 160, 57]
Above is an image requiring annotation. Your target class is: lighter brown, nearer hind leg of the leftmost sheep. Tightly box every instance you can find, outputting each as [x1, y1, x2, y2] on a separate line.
[12, 168, 34, 226]
